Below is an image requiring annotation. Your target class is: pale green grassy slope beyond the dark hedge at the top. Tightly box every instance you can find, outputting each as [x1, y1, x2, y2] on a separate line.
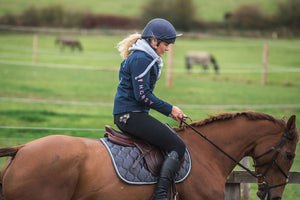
[0, 0, 286, 21]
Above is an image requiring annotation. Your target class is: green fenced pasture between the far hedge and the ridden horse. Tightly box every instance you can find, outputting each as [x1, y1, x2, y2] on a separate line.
[0, 33, 300, 199]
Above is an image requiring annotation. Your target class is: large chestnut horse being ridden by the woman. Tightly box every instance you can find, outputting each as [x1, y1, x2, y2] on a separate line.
[0, 112, 299, 200]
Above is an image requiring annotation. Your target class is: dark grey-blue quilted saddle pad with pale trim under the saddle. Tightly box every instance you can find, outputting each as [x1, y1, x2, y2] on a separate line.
[100, 138, 192, 185]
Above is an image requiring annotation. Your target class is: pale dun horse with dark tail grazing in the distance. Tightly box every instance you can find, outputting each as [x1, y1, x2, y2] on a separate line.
[185, 52, 219, 74]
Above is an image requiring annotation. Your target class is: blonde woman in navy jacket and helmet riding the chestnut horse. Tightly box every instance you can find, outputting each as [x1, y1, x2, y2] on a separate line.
[113, 18, 186, 200]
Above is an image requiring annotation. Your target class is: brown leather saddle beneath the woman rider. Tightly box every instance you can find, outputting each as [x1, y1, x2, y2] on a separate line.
[104, 125, 167, 176]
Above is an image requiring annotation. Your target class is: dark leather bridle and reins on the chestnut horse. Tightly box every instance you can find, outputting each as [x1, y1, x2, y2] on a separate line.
[179, 117, 293, 193]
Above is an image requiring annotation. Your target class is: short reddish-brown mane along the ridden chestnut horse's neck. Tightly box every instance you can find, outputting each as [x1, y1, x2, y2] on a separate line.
[174, 111, 284, 131]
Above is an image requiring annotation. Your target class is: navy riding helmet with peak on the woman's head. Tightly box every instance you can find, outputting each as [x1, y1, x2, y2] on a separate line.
[142, 18, 182, 44]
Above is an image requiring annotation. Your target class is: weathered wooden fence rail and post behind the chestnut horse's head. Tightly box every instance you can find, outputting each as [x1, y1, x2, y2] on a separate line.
[225, 170, 300, 200]
